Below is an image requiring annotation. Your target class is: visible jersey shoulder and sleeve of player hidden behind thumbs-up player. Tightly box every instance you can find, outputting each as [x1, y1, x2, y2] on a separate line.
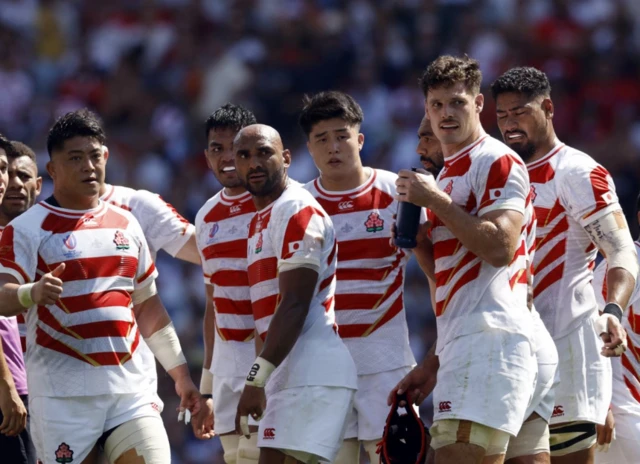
[100, 184, 195, 259]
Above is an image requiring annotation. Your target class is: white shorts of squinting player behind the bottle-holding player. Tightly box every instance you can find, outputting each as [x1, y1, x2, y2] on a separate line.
[550, 313, 612, 424]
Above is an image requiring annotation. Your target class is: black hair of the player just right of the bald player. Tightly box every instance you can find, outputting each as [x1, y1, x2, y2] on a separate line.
[298, 90, 364, 137]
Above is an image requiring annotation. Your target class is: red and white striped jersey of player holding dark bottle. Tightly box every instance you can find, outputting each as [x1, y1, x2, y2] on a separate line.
[428, 135, 531, 353]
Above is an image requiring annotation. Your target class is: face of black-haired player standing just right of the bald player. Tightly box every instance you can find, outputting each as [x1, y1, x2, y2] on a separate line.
[307, 118, 364, 177]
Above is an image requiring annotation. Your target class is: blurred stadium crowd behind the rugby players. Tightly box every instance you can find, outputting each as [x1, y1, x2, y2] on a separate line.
[0, 0, 640, 464]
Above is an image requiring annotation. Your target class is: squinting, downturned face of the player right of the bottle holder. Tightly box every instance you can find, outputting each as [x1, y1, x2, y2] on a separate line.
[496, 92, 550, 161]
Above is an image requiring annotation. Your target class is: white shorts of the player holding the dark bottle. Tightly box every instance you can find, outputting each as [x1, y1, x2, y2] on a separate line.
[433, 329, 537, 436]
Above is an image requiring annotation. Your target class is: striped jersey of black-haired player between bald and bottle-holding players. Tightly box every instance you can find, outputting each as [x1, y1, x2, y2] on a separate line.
[305, 169, 415, 375]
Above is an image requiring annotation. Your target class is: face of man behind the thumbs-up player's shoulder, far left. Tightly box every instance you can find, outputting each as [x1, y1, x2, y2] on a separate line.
[0, 156, 42, 219]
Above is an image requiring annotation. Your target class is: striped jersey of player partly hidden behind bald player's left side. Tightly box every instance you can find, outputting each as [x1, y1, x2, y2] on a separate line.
[196, 190, 256, 376]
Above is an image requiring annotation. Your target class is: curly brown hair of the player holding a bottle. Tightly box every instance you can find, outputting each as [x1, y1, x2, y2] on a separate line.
[419, 55, 482, 97]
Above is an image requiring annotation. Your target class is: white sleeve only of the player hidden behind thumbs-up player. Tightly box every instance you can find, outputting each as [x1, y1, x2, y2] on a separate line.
[130, 190, 195, 256]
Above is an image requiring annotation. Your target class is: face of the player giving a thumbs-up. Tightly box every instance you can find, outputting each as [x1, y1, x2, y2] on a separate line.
[47, 136, 107, 197]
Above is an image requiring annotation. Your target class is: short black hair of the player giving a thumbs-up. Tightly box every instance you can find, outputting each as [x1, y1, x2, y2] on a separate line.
[47, 108, 107, 156]
